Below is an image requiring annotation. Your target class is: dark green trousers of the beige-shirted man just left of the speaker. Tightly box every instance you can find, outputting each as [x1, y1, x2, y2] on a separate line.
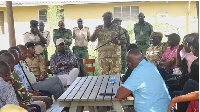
[73, 46, 89, 59]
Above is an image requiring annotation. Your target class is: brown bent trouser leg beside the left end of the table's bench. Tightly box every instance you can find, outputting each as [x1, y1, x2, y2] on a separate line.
[32, 96, 53, 109]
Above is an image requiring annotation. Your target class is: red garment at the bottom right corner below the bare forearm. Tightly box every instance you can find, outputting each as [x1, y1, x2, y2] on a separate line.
[186, 100, 199, 112]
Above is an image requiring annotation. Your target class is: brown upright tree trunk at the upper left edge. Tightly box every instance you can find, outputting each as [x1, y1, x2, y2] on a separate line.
[6, 1, 16, 47]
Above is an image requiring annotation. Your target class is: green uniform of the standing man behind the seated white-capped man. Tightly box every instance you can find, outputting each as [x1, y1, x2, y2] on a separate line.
[53, 28, 72, 50]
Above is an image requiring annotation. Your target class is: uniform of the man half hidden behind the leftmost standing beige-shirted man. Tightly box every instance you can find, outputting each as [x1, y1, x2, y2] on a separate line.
[40, 30, 51, 61]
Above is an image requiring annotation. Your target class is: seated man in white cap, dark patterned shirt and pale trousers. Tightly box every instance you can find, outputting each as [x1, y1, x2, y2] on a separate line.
[50, 38, 79, 86]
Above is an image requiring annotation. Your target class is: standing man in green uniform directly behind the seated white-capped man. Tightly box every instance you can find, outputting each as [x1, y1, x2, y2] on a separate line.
[53, 20, 72, 50]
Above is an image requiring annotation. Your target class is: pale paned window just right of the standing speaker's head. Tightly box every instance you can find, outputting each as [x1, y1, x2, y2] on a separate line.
[114, 6, 139, 21]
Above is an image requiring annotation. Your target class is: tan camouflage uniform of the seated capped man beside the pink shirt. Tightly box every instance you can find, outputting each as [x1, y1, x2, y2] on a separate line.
[145, 43, 168, 65]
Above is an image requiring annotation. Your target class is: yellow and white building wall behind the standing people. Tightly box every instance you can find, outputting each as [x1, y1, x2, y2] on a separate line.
[0, 1, 197, 50]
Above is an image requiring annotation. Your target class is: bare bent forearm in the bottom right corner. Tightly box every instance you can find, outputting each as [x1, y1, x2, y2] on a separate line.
[167, 91, 199, 112]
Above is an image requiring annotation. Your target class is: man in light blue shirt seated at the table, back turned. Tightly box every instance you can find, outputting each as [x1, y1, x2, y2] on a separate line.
[116, 49, 171, 112]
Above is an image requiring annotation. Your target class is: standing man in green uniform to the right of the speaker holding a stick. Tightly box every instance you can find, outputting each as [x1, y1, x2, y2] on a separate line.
[134, 12, 153, 54]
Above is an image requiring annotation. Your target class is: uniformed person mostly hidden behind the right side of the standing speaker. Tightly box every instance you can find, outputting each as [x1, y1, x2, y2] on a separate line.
[112, 18, 130, 74]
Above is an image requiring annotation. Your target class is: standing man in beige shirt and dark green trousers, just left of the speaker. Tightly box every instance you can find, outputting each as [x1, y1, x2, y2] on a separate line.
[73, 18, 90, 58]
